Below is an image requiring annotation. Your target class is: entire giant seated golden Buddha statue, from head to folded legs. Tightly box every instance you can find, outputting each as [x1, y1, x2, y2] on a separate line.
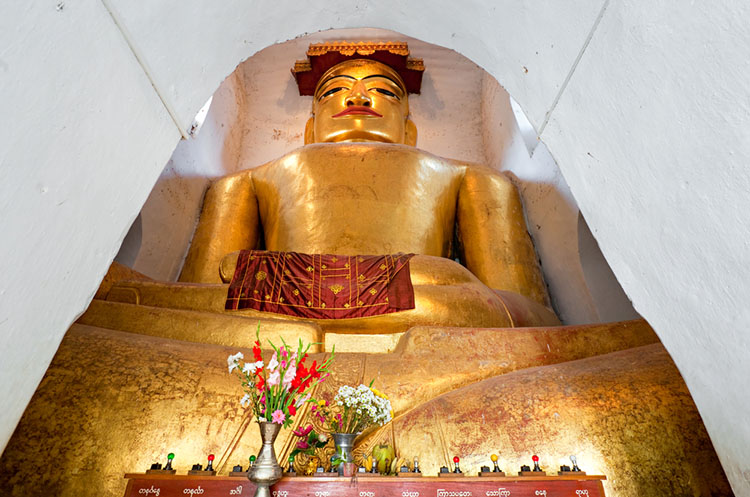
[0, 44, 729, 497]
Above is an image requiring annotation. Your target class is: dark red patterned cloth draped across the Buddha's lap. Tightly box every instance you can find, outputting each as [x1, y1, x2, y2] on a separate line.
[225, 250, 414, 319]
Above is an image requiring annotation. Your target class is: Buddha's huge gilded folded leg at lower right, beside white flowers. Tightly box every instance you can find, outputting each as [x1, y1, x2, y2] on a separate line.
[355, 343, 731, 497]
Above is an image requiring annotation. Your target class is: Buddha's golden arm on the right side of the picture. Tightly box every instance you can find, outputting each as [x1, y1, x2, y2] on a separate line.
[457, 167, 549, 305]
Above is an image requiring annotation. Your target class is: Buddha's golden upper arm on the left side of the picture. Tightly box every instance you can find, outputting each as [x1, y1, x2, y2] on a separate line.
[180, 171, 260, 283]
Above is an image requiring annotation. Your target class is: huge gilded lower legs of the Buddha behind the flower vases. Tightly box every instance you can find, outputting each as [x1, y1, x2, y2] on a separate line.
[0, 322, 730, 497]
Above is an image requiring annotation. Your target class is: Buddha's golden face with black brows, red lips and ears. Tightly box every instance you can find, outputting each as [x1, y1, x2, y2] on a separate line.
[305, 59, 416, 145]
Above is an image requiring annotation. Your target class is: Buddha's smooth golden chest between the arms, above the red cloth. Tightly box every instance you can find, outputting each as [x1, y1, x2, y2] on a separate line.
[253, 144, 462, 255]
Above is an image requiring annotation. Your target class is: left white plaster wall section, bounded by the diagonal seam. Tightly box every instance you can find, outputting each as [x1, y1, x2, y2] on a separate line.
[0, 1, 179, 447]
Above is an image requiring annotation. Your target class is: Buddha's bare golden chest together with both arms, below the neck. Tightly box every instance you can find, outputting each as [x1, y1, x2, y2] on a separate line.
[182, 143, 546, 303]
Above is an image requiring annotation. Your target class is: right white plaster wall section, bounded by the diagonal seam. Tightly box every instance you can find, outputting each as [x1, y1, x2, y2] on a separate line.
[542, 0, 750, 495]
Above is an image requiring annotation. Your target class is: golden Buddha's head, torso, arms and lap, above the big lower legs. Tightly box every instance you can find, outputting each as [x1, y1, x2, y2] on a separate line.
[86, 43, 559, 351]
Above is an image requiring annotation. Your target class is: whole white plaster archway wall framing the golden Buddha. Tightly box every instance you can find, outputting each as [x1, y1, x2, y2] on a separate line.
[0, 0, 750, 495]
